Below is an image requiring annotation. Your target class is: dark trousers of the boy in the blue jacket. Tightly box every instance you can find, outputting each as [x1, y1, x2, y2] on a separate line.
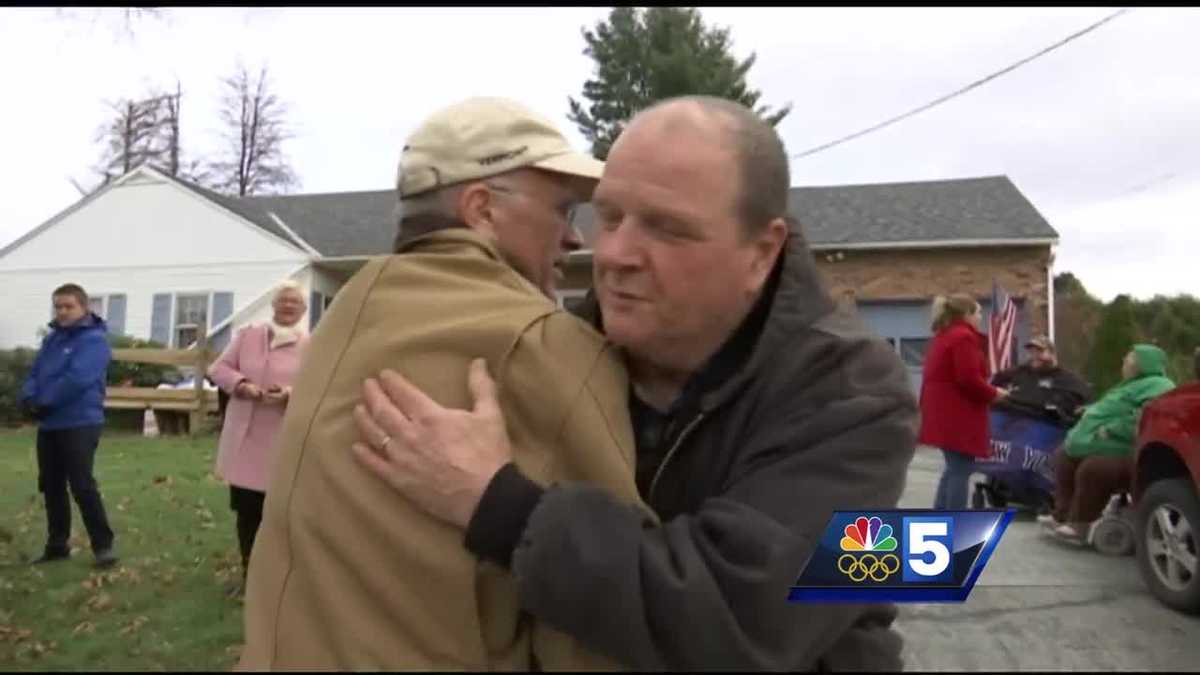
[37, 425, 113, 554]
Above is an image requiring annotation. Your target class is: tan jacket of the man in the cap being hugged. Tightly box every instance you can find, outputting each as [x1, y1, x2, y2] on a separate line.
[239, 229, 640, 670]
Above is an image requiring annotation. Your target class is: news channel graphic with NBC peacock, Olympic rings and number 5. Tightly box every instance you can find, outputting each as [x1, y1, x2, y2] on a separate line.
[787, 509, 1016, 603]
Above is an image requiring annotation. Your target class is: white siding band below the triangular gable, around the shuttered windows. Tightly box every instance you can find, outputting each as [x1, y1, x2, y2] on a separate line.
[0, 260, 304, 348]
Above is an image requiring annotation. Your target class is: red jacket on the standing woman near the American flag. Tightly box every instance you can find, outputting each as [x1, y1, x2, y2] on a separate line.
[918, 321, 997, 458]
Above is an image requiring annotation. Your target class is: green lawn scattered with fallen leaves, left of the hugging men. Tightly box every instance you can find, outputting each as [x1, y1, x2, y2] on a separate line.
[0, 430, 241, 670]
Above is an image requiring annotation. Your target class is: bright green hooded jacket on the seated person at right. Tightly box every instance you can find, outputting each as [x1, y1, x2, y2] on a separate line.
[1066, 345, 1175, 458]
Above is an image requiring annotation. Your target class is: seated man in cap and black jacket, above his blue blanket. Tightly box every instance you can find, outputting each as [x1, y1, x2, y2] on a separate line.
[991, 335, 1092, 429]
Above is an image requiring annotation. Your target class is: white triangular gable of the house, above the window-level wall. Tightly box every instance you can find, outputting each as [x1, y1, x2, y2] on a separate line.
[0, 174, 307, 269]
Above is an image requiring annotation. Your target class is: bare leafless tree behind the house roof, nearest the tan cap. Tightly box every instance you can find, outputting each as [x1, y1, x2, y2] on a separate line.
[209, 64, 300, 197]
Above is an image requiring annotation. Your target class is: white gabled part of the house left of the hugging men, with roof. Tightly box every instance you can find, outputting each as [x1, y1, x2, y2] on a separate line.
[0, 166, 396, 348]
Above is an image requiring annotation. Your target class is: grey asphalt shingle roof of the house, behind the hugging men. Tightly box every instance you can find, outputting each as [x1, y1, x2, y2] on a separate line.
[185, 175, 1058, 257]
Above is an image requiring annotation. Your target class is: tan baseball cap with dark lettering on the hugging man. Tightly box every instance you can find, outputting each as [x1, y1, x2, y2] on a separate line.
[396, 96, 604, 199]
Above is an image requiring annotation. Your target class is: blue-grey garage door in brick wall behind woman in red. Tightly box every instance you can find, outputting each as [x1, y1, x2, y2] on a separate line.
[858, 300, 1028, 394]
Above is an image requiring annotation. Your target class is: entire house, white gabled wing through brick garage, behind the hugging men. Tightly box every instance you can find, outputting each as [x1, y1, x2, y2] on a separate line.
[7, 166, 1058, 387]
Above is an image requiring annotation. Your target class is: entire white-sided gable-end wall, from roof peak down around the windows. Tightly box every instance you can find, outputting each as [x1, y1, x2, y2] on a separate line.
[0, 171, 319, 348]
